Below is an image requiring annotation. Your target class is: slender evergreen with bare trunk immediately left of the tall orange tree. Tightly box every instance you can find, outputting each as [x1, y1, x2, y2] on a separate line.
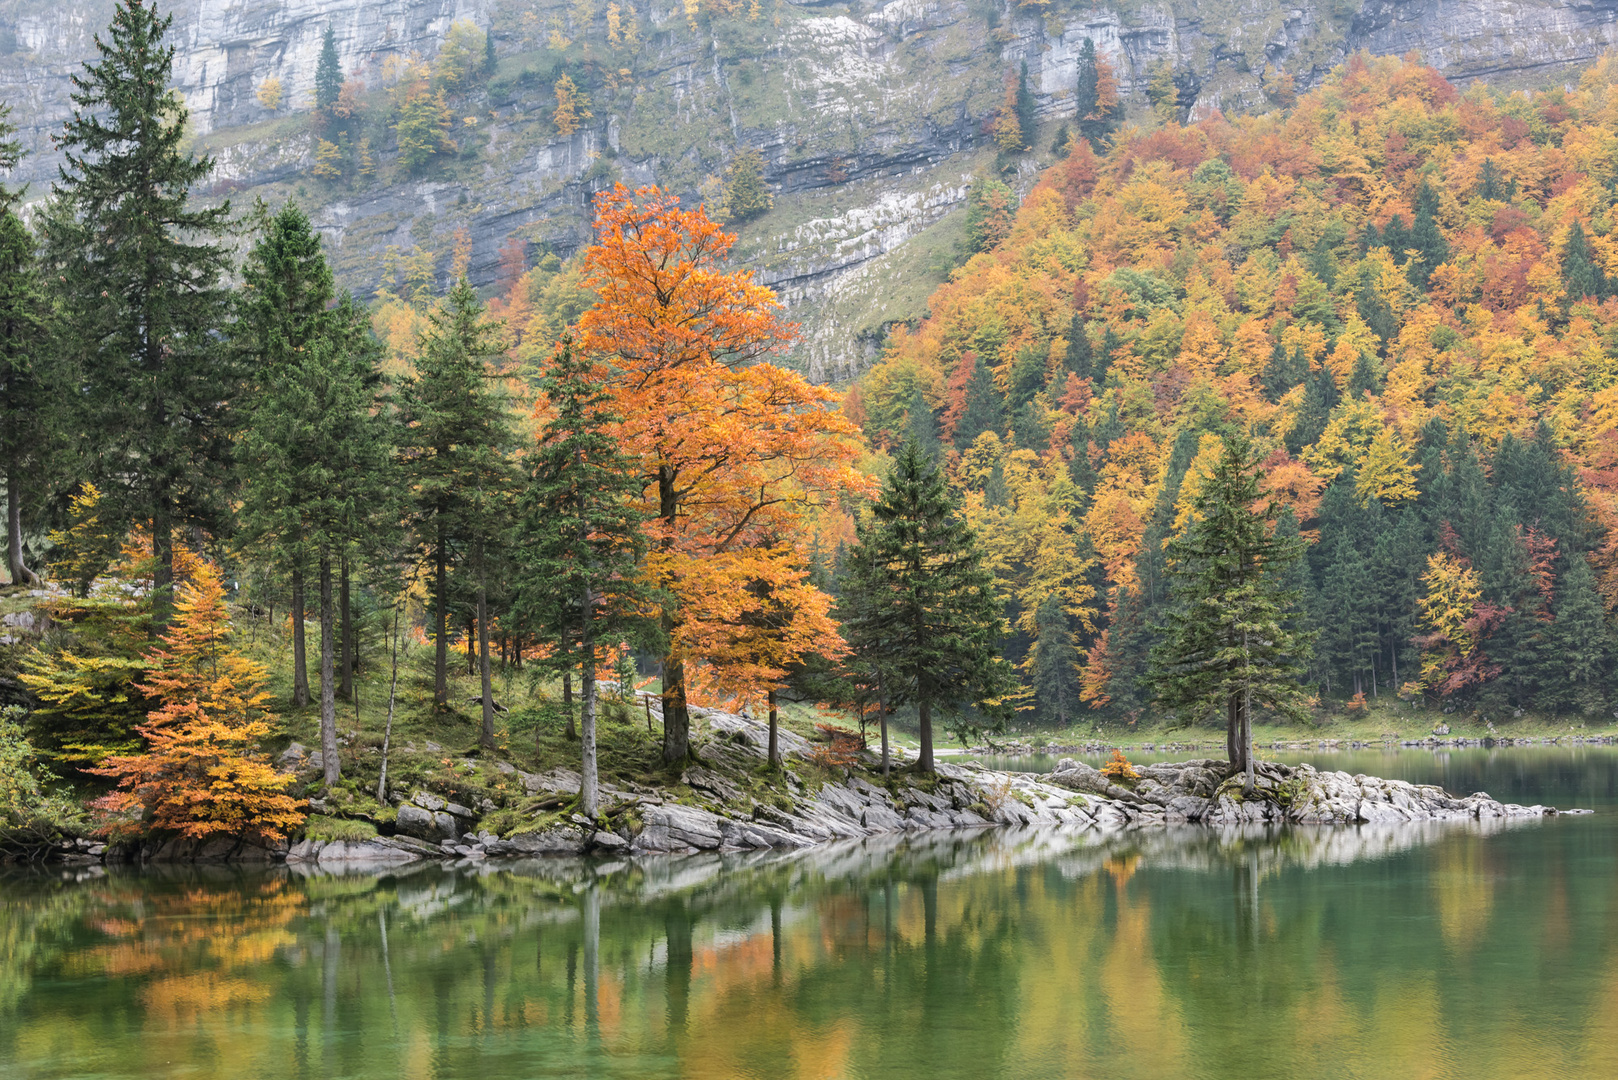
[518, 338, 647, 818]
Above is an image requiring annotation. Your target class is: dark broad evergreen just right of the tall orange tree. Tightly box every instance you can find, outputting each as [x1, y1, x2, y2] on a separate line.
[845, 442, 1011, 774]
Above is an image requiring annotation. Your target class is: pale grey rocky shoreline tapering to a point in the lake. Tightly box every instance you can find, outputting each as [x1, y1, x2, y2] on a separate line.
[22, 712, 1584, 866]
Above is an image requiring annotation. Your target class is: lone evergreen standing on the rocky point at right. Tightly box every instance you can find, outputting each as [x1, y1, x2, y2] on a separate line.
[1150, 436, 1311, 789]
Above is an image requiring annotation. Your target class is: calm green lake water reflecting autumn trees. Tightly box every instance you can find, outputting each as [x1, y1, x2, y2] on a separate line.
[0, 750, 1618, 1080]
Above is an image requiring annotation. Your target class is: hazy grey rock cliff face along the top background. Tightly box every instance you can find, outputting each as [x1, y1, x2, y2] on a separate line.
[0, 0, 1618, 379]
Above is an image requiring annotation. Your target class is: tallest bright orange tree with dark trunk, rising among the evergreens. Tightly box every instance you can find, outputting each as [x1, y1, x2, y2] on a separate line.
[578, 185, 866, 761]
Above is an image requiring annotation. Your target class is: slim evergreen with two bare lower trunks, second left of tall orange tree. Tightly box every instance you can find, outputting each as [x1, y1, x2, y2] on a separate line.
[400, 277, 515, 746]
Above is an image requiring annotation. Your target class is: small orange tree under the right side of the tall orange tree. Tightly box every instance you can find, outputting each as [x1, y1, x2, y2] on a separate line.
[675, 544, 848, 766]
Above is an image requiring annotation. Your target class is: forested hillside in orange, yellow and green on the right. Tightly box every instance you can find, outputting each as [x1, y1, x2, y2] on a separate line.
[845, 57, 1618, 722]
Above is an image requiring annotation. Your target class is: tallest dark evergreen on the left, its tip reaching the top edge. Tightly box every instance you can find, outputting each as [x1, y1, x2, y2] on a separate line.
[47, 0, 241, 627]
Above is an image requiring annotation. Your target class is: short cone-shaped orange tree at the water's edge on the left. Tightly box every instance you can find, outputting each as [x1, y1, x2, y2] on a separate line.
[91, 562, 304, 840]
